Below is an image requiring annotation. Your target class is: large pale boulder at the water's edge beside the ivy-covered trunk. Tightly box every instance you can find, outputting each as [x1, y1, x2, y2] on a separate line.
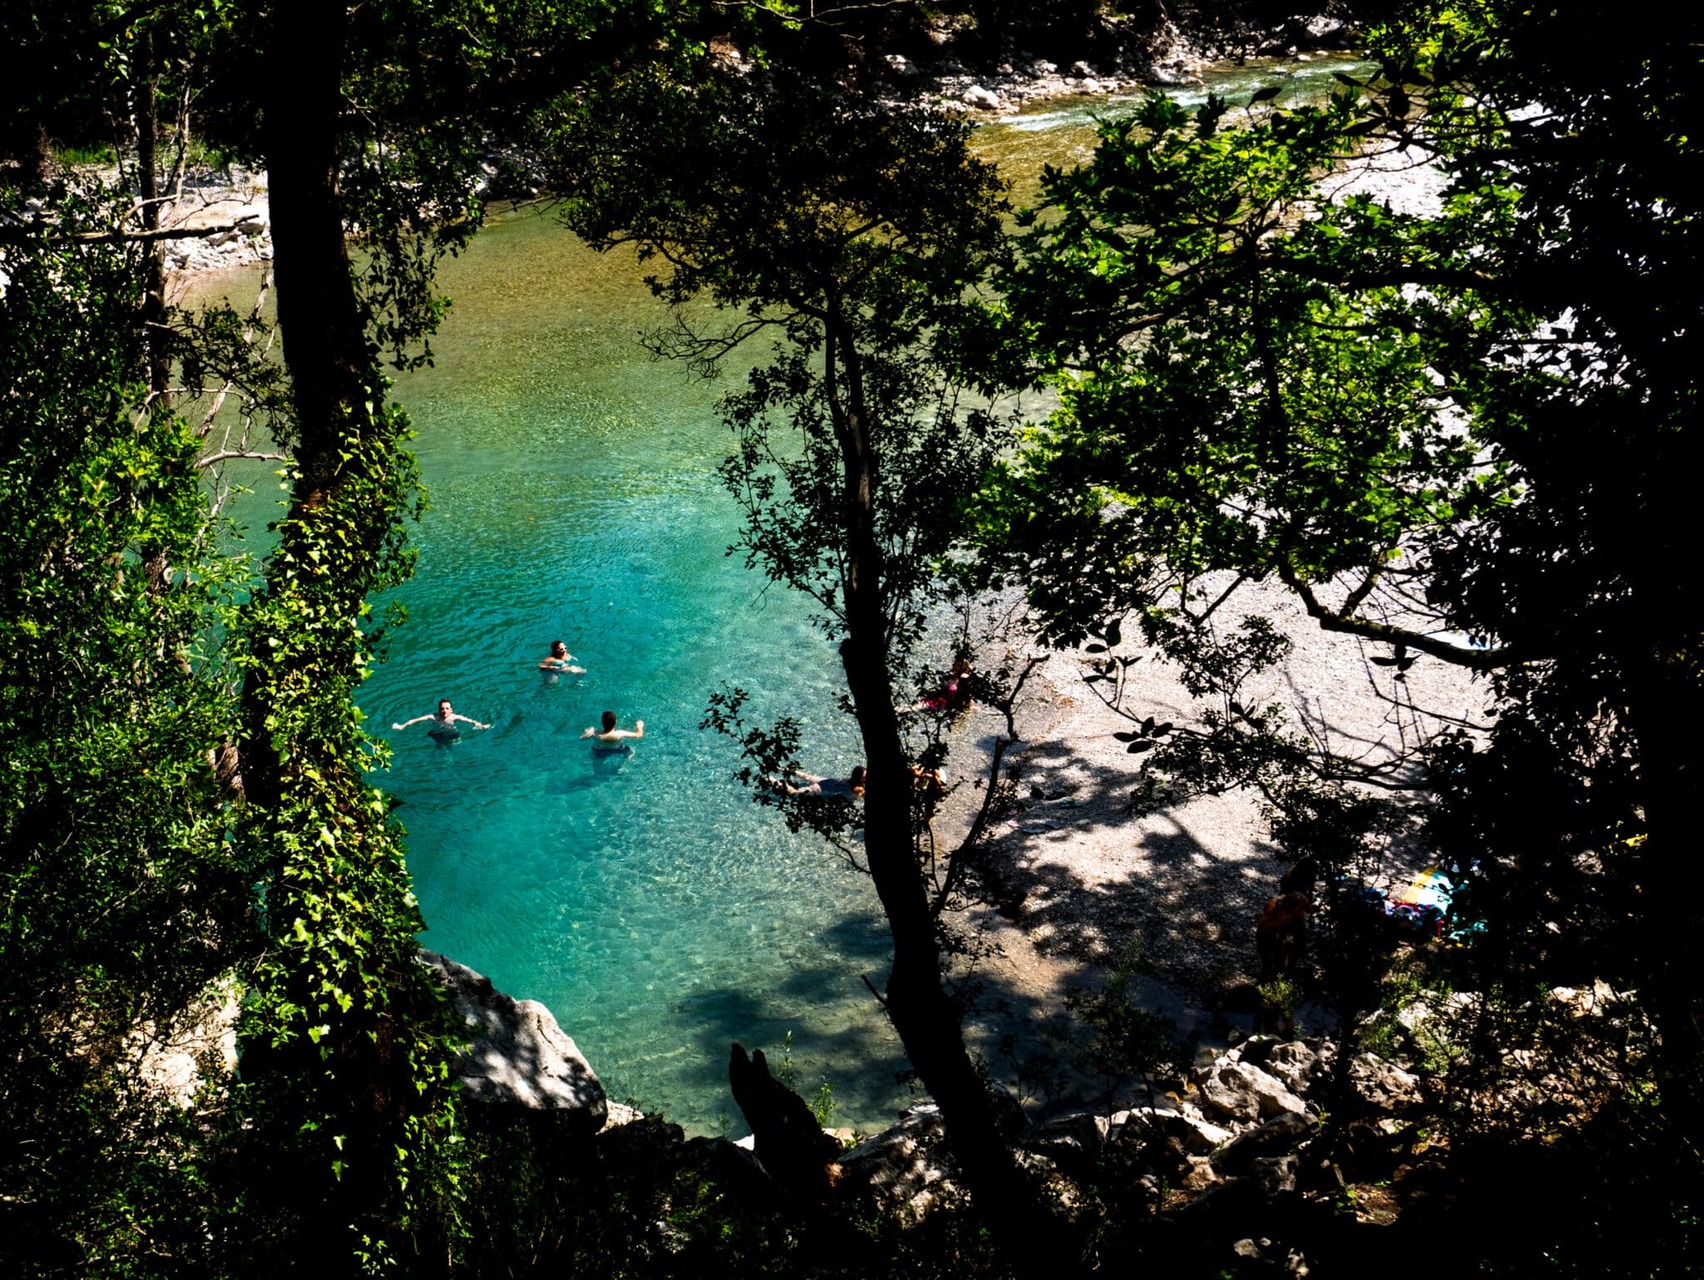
[421, 951, 608, 1137]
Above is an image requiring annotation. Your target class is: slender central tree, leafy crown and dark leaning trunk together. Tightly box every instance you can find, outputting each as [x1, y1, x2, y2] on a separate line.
[562, 57, 1076, 1271]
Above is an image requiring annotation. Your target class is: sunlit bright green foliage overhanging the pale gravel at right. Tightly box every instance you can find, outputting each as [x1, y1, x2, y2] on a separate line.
[990, 85, 1511, 651]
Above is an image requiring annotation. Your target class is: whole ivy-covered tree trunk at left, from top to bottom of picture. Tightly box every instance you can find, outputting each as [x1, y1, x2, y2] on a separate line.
[240, 0, 455, 1273]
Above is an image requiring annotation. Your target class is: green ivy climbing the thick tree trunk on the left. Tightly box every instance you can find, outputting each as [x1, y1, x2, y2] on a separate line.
[239, 397, 465, 1273]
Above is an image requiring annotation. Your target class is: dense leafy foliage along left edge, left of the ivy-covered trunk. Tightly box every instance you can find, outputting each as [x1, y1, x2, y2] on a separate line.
[0, 178, 259, 1275]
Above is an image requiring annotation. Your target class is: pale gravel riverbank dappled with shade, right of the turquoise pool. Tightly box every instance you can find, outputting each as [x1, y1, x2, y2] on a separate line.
[941, 586, 1486, 1097]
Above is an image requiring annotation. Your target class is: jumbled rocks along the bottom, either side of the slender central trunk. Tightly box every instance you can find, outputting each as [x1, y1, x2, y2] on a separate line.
[538, 1015, 1440, 1277]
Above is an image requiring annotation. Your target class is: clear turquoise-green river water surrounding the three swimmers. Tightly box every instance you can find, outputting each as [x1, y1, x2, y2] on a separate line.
[213, 61, 1344, 1133]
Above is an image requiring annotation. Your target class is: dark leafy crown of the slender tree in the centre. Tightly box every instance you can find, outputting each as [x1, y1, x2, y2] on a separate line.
[559, 60, 1004, 821]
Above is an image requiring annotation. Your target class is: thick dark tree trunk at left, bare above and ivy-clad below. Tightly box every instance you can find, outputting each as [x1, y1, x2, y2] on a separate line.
[242, 0, 431, 1273]
